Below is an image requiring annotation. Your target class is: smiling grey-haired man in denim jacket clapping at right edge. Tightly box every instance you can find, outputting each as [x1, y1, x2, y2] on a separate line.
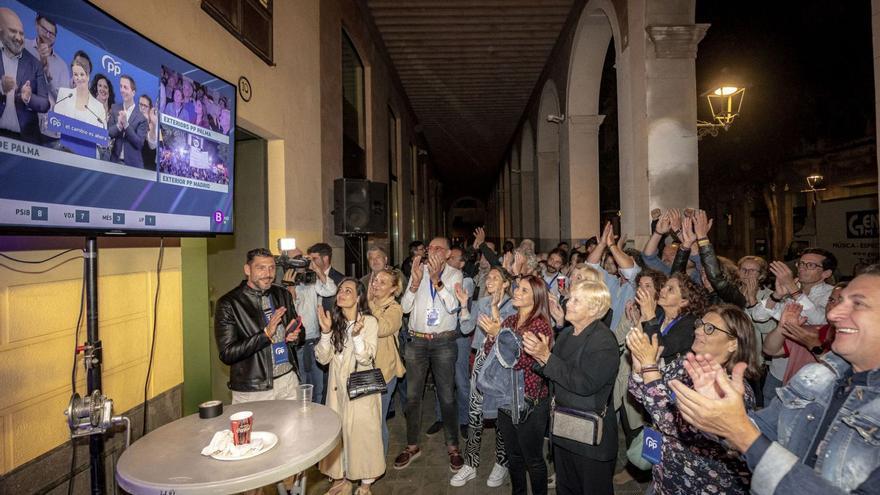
[673, 265, 880, 495]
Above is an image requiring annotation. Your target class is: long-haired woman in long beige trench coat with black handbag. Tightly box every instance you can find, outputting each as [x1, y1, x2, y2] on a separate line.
[315, 278, 385, 495]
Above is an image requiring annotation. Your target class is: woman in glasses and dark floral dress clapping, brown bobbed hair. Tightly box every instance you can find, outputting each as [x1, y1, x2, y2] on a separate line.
[626, 304, 759, 495]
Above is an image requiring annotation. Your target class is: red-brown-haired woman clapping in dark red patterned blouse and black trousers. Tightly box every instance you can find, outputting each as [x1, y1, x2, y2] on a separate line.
[479, 275, 553, 495]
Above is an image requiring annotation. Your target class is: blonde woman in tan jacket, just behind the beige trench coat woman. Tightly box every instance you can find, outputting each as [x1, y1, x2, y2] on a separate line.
[367, 267, 406, 454]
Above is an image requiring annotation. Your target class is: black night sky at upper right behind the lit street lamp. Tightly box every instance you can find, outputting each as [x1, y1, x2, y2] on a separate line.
[696, 0, 874, 178]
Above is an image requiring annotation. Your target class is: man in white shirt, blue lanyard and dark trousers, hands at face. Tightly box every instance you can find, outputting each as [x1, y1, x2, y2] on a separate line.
[394, 237, 464, 472]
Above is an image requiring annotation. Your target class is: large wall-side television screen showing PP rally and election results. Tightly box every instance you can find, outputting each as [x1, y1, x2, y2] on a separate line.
[0, 0, 236, 235]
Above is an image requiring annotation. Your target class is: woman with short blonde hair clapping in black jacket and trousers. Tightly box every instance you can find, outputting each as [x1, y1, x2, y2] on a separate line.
[523, 281, 620, 495]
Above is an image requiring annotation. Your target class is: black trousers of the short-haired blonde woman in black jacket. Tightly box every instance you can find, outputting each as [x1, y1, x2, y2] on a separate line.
[553, 445, 615, 495]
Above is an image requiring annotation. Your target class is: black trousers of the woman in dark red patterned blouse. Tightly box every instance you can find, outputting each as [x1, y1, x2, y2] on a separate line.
[497, 398, 558, 495]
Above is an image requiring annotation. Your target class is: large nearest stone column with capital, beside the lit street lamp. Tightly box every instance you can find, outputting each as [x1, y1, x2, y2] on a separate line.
[636, 24, 709, 211]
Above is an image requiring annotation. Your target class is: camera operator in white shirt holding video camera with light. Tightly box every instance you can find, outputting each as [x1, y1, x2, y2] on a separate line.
[282, 249, 336, 404]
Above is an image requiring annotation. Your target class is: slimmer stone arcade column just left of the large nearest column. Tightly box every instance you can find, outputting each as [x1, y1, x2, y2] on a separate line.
[562, 115, 605, 240]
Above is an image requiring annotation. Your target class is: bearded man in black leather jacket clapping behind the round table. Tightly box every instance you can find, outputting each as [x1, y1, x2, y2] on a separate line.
[214, 248, 304, 403]
